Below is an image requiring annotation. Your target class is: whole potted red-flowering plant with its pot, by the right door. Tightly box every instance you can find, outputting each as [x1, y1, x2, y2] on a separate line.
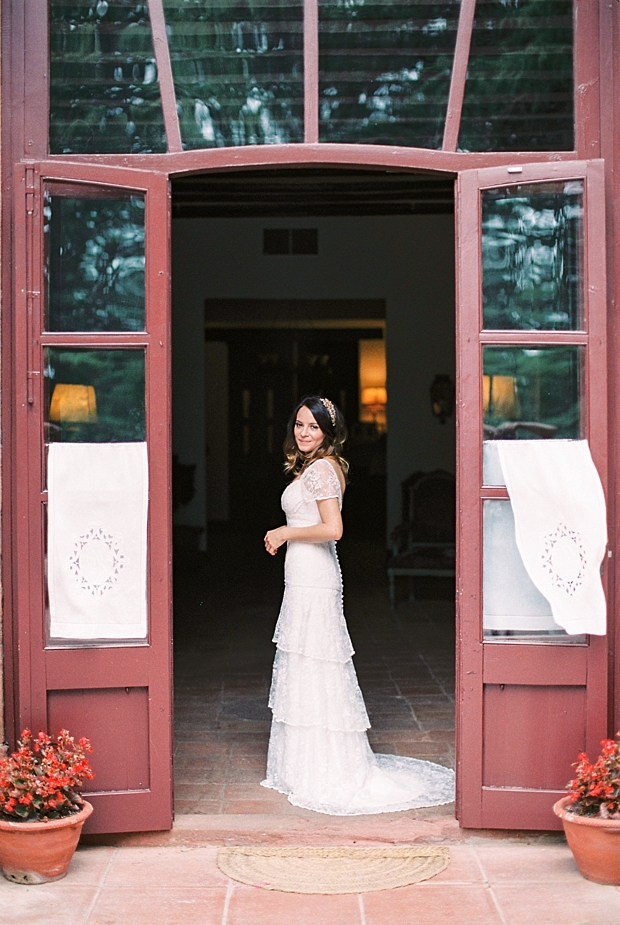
[553, 733, 620, 886]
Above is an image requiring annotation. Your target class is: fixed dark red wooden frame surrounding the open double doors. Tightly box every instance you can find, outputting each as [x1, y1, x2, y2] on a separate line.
[1, 0, 620, 836]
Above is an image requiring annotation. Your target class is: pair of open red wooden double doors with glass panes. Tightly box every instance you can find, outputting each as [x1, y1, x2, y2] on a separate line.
[12, 160, 607, 832]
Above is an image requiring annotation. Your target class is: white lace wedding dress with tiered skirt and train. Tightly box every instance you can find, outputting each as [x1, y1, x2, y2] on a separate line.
[262, 459, 454, 816]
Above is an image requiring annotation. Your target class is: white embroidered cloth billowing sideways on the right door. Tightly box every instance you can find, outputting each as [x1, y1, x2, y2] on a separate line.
[497, 440, 607, 636]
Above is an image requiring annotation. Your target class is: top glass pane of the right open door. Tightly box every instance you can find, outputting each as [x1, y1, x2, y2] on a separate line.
[482, 180, 584, 331]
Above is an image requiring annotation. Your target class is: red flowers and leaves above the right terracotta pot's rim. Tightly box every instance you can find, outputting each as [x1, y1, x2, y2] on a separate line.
[566, 732, 620, 819]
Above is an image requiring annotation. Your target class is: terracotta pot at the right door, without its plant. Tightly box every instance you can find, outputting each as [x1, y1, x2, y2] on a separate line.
[553, 797, 620, 886]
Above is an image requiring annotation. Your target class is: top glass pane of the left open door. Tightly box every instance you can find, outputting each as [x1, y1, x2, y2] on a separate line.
[44, 191, 145, 331]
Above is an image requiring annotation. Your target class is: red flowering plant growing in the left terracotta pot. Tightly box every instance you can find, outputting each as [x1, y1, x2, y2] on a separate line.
[0, 729, 94, 822]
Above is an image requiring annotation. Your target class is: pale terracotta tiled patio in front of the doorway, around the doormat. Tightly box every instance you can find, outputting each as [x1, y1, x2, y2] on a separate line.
[0, 836, 620, 925]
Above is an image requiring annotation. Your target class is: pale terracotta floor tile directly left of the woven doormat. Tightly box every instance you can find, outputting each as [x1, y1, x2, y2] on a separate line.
[105, 847, 228, 890]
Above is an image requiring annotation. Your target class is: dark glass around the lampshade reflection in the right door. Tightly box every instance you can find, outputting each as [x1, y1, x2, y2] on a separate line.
[483, 346, 583, 440]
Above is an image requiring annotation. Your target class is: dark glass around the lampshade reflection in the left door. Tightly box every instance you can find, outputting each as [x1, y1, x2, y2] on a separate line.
[45, 347, 146, 443]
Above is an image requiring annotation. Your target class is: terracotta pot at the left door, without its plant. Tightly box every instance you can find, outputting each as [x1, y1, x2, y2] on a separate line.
[0, 802, 93, 884]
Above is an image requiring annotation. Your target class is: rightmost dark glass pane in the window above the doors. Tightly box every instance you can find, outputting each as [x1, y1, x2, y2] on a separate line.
[459, 0, 574, 151]
